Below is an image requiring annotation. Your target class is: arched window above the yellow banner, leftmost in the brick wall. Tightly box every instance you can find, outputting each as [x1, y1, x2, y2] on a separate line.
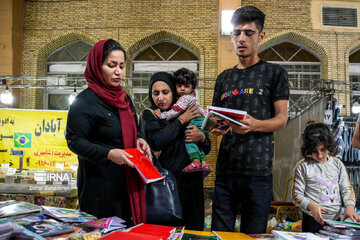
[44, 40, 92, 110]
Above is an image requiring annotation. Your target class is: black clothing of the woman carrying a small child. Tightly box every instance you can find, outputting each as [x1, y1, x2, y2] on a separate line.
[140, 110, 211, 230]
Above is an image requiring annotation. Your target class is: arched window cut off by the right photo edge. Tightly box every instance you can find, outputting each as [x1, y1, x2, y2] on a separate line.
[349, 49, 360, 114]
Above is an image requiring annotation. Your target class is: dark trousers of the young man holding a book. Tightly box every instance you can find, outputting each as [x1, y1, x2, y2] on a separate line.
[211, 175, 272, 234]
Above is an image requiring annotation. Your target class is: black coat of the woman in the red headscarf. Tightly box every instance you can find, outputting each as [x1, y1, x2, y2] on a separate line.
[66, 88, 137, 224]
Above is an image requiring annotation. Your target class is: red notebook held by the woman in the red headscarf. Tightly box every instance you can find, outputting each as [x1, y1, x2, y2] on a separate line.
[124, 148, 164, 183]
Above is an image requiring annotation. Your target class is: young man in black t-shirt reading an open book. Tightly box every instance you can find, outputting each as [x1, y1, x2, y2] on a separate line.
[211, 6, 289, 233]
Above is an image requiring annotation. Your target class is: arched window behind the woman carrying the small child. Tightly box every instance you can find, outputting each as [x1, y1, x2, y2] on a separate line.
[128, 40, 199, 112]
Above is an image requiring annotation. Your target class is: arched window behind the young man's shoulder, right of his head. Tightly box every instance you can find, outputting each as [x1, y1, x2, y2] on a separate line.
[259, 42, 321, 105]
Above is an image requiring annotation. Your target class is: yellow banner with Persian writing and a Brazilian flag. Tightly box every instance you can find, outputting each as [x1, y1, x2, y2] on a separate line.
[0, 109, 77, 169]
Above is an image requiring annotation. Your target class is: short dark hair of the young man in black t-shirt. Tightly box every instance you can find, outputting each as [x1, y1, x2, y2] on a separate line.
[231, 6, 265, 32]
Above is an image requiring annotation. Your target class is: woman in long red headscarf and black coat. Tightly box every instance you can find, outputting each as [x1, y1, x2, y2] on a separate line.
[66, 39, 151, 225]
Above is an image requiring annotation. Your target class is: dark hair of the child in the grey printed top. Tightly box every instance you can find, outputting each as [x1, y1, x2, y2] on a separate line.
[301, 122, 336, 158]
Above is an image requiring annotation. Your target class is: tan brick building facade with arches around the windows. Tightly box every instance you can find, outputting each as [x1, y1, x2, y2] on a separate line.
[0, 0, 360, 186]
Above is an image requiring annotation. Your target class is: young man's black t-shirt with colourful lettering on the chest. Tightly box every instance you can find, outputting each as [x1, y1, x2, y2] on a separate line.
[213, 60, 289, 176]
